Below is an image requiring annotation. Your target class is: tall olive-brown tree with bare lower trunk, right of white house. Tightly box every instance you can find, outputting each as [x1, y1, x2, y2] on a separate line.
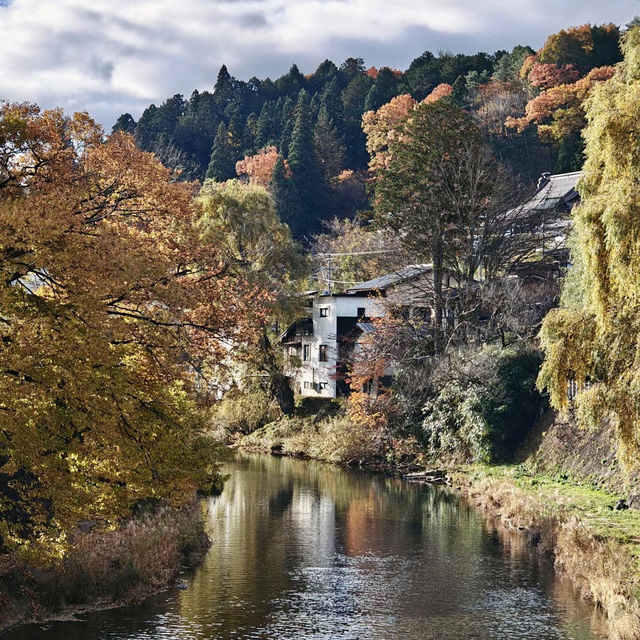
[374, 101, 486, 328]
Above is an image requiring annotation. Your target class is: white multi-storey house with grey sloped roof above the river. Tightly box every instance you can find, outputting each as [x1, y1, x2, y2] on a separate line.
[280, 265, 432, 398]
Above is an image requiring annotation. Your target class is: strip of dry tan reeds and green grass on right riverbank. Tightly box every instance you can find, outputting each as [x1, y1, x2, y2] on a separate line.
[454, 468, 640, 640]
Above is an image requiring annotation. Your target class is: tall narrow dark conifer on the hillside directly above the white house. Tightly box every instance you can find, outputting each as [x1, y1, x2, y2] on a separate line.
[289, 89, 326, 238]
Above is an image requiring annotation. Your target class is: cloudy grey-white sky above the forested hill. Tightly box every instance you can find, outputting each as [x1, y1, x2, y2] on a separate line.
[0, 0, 640, 128]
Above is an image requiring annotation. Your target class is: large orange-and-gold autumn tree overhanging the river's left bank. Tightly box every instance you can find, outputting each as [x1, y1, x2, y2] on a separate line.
[0, 104, 269, 551]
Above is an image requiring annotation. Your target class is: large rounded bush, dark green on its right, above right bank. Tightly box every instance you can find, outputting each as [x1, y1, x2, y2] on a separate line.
[422, 344, 543, 462]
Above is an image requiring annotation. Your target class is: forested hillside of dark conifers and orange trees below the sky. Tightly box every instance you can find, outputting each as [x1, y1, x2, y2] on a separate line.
[114, 25, 621, 238]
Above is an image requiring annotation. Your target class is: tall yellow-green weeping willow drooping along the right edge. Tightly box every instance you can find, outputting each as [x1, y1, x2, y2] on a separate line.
[538, 27, 640, 462]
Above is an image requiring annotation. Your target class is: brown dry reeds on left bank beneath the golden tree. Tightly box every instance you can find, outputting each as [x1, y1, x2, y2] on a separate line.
[0, 500, 210, 631]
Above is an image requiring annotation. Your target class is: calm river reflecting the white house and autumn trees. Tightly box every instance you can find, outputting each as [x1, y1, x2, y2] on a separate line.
[3, 456, 604, 640]
